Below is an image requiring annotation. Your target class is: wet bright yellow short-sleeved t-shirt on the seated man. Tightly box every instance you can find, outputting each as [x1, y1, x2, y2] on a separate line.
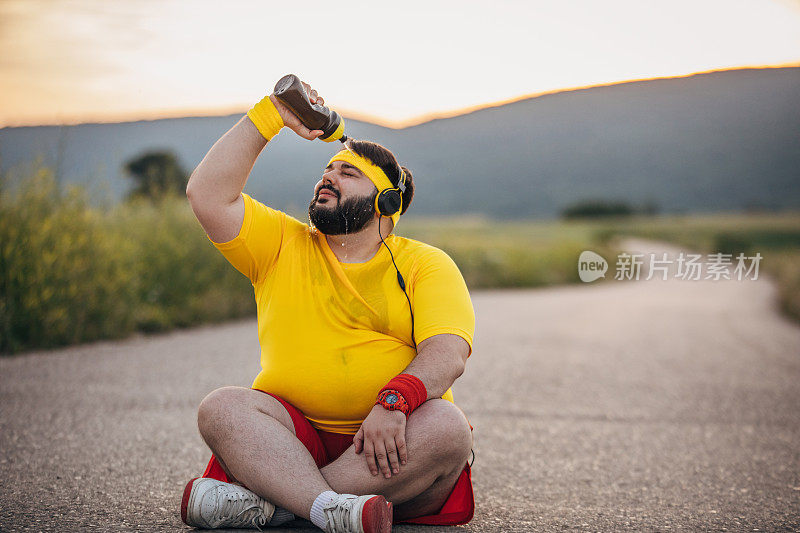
[214, 194, 475, 435]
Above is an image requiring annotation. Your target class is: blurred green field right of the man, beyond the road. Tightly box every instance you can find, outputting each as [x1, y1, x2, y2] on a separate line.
[398, 212, 800, 320]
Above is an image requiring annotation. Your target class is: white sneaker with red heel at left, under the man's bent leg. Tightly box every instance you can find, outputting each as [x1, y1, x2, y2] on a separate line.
[181, 477, 275, 529]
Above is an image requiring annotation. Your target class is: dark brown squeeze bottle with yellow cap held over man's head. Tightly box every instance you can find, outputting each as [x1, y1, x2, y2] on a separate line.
[274, 74, 347, 142]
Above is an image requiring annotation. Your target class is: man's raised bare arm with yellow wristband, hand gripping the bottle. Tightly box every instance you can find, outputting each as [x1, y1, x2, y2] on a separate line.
[186, 83, 324, 242]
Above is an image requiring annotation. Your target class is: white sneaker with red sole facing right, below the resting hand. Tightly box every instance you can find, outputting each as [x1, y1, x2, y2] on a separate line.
[322, 494, 392, 533]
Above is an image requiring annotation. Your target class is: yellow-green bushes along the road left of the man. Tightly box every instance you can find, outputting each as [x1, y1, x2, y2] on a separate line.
[0, 162, 255, 353]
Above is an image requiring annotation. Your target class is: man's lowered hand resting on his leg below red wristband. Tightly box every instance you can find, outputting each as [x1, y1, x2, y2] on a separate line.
[353, 405, 408, 479]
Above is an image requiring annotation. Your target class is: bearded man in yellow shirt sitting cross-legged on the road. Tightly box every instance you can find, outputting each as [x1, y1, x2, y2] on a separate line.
[181, 79, 475, 533]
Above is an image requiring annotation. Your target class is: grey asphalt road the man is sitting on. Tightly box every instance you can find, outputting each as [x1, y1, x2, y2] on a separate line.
[0, 242, 800, 533]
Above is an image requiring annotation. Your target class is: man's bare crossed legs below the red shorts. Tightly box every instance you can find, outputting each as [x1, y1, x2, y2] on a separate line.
[187, 387, 472, 531]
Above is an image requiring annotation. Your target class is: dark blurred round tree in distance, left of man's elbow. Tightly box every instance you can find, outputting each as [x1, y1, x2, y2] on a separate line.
[125, 151, 189, 200]
